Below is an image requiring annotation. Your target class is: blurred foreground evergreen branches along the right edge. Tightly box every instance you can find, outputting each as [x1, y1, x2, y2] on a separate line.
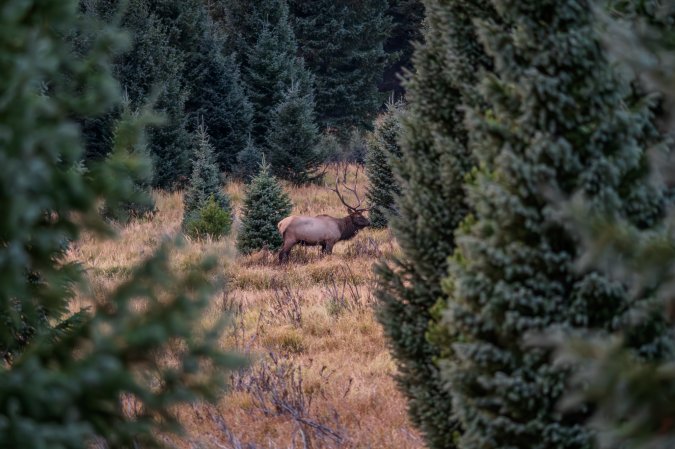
[559, 2, 675, 449]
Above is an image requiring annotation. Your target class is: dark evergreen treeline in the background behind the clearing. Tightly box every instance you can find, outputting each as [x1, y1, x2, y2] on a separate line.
[79, 0, 422, 190]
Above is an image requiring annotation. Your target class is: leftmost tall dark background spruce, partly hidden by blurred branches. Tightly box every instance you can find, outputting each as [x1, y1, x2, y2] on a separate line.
[78, 0, 190, 188]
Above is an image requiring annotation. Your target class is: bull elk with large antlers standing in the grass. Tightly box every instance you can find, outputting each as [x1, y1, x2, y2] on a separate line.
[277, 171, 370, 262]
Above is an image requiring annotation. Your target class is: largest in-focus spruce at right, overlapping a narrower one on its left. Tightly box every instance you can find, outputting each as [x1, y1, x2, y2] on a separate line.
[432, 0, 669, 449]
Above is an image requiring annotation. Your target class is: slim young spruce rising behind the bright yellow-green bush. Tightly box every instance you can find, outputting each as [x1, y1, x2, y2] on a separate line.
[183, 125, 232, 229]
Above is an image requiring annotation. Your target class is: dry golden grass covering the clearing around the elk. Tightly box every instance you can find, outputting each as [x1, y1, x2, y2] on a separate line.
[70, 164, 423, 449]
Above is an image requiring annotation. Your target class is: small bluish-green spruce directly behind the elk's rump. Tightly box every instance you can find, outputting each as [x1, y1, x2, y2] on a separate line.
[237, 158, 293, 254]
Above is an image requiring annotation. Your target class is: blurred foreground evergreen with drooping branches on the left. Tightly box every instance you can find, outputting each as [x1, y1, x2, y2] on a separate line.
[0, 0, 243, 449]
